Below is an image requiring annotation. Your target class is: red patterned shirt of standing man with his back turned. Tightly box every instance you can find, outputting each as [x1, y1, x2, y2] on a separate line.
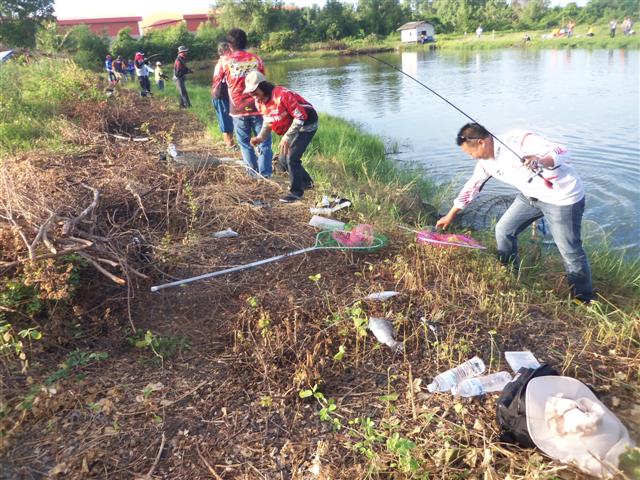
[213, 50, 264, 117]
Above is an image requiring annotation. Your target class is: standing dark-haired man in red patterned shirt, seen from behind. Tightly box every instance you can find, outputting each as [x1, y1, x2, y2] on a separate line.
[213, 28, 273, 178]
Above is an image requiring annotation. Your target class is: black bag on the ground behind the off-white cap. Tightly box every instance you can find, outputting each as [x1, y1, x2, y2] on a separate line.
[496, 364, 559, 448]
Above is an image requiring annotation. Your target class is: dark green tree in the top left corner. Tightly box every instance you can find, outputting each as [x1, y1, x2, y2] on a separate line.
[0, 0, 53, 47]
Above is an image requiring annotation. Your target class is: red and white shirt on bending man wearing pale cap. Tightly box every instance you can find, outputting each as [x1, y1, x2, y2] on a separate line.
[256, 87, 318, 140]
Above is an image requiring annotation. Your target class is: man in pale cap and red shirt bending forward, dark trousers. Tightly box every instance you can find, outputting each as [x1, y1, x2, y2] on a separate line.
[244, 71, 318, 203]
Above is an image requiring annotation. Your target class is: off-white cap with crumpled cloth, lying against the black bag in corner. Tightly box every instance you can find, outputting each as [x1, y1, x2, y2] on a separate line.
[525, 376, 634, 479]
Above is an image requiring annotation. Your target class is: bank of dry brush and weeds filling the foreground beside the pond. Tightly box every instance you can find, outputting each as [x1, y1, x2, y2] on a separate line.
[0, 61, 640, 480]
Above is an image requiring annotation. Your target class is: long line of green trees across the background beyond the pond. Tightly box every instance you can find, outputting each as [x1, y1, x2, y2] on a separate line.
[0, 0, 638, 68]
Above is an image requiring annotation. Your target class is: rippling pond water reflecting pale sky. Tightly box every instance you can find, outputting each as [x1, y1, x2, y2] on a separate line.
[196, 49, 640, 256]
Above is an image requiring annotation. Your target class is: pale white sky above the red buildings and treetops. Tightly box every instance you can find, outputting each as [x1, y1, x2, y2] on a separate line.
[54, 0, 587, 20]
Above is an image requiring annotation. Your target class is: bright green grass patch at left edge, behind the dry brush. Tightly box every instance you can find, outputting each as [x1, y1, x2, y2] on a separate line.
[0, 59, 98, 153]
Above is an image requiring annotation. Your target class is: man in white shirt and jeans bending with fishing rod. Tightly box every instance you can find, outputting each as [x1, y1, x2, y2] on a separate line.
[436, 123, 593, 302]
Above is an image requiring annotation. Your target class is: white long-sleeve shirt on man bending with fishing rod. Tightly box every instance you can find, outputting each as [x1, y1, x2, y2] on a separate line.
[453, 130, 584, 209]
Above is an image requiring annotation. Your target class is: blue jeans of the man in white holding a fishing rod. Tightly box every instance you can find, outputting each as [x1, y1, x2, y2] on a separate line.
[496, 193, 593, 300]
